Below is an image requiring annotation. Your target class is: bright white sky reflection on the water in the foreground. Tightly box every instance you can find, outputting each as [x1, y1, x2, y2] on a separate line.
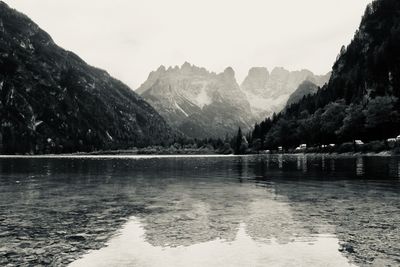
[70, 217, 354, 267]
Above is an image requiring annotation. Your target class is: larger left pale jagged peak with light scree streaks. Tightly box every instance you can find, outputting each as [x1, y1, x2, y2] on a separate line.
[137, 63, 254, 138]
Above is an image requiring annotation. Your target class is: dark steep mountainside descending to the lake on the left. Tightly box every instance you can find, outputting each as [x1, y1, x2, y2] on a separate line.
[0, 2, 172, 153]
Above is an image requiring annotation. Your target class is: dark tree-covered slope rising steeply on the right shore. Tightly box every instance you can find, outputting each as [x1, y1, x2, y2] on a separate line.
[247, 0, 400, 149]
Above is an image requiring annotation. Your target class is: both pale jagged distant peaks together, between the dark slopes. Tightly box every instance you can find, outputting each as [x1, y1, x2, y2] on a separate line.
[136, 62, 330, 138]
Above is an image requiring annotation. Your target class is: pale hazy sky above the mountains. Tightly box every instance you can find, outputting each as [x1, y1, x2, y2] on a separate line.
[5, 0, 371, 89]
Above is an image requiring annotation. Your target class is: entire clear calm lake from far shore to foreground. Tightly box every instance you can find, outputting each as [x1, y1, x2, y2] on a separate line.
[0, 155, 400, 267]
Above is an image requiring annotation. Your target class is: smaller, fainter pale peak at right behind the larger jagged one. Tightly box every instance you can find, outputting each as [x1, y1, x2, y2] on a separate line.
[241, 68, 330, 118]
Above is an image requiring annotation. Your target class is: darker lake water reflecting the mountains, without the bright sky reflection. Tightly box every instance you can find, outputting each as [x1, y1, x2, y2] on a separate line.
[0, 155, 400, 265]
